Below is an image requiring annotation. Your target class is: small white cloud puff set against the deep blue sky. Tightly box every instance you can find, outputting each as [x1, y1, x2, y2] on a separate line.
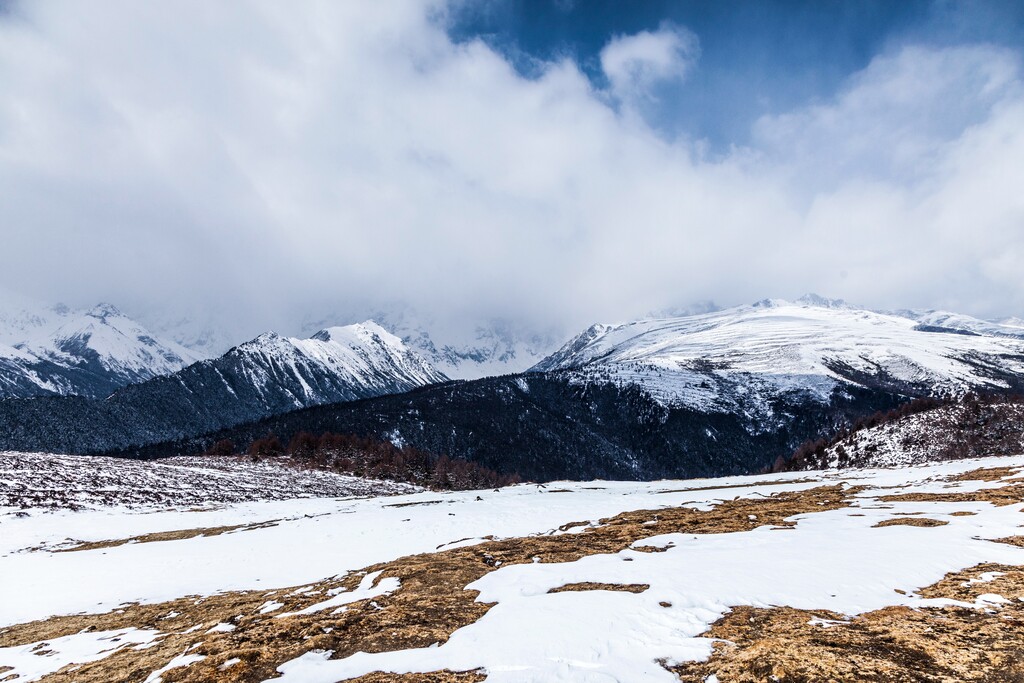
[600, 22, 700, 103]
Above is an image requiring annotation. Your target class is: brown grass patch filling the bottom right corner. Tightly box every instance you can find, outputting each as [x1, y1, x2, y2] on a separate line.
[671, 564, 1024, 683]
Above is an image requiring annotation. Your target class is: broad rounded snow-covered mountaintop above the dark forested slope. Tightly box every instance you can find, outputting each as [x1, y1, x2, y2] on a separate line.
[534, 296, 1024, 419]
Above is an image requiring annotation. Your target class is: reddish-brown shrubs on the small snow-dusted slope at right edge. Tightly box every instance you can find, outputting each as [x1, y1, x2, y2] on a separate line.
[768, 392, 1024, 472]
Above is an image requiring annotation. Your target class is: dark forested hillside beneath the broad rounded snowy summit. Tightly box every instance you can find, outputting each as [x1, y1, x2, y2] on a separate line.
[146, 373, 902, 481]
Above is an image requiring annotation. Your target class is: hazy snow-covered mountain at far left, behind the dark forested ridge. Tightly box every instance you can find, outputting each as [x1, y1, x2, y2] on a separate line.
[0, 304, 200, 398]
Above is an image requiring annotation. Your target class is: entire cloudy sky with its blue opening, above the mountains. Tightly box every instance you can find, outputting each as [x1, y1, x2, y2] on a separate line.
[0, 0, 1024, 342]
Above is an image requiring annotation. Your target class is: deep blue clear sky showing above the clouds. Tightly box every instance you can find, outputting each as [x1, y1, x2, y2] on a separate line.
[450, 0, 1024, 146]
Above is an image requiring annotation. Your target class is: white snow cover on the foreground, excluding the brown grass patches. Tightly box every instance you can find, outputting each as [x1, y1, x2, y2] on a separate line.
[0, 456, 1024, 683]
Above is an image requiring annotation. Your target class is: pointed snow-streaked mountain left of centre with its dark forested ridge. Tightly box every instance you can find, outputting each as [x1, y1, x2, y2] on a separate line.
[0, 322, 447, 453]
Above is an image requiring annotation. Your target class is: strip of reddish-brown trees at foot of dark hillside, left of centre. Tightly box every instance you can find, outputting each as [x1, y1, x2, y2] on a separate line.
[206, 431, 519, 490]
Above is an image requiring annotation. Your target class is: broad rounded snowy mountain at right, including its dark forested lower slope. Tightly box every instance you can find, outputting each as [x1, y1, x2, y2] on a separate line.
[142, 297, 1024, 480]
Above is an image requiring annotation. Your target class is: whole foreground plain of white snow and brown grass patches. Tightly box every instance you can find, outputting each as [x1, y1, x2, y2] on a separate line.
[0, 455, 1024, 683]
